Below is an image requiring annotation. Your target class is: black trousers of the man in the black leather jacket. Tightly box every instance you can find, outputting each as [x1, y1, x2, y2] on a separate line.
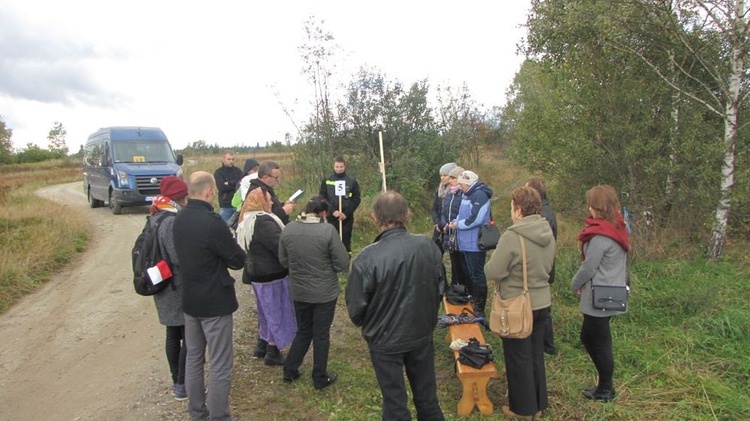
[370, 342, 444, 421]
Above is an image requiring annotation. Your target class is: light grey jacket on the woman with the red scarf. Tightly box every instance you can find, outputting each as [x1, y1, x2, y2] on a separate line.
[570, 235, 628, 317]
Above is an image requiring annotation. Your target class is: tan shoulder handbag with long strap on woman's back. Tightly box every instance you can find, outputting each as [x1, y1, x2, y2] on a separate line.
[490, 235, 534, 339]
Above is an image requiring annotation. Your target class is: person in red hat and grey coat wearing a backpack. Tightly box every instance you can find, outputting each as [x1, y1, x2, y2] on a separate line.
[149, 175, 188, 401]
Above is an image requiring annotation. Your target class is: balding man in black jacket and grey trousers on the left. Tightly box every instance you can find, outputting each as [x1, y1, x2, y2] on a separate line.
[173, 171, 246, 420]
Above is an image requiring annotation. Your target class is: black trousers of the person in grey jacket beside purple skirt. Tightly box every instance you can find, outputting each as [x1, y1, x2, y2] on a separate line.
[284, 300, 336, 386]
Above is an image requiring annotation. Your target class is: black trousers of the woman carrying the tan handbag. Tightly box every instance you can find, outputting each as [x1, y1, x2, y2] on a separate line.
[503, 307, 549, 415]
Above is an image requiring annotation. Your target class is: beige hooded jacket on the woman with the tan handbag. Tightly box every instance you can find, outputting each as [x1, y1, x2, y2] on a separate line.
[484, 215, 556, 310]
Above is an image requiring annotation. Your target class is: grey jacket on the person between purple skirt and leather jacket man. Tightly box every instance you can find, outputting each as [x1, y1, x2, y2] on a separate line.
[279, 217, 349, 303]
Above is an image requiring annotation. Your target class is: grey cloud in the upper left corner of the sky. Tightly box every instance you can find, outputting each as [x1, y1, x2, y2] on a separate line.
[0, 9, 125, 106]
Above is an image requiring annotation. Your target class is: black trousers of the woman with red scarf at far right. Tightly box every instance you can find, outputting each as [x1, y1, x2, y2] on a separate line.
[581, 314, 615, 390]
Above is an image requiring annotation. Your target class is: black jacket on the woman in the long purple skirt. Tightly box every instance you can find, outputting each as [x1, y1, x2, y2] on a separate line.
[242, 215, 289, 284]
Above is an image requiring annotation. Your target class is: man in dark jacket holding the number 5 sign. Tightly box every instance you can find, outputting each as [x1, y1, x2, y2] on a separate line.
[318, 156, 362, 251]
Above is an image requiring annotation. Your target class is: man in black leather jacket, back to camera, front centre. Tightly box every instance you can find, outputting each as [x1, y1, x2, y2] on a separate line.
[346, 191, 445, 420]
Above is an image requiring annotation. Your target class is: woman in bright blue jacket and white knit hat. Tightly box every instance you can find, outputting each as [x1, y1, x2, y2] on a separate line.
[449, 171, 492, 317]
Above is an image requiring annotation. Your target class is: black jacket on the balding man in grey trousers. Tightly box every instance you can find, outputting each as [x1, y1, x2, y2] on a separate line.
[172, 199, 245, 317]
